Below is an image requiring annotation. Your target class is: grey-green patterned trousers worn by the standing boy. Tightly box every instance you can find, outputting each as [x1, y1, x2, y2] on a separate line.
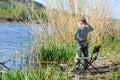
[75, 41, 88, 68]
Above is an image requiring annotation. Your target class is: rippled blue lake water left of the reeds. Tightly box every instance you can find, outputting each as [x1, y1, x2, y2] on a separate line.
[0, 23, 32, 68]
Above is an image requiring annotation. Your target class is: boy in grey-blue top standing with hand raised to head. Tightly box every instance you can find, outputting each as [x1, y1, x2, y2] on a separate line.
[72, 18, 93, 72]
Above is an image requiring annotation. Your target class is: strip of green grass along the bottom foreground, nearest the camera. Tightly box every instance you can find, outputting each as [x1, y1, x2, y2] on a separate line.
[1, 66, 70, 80]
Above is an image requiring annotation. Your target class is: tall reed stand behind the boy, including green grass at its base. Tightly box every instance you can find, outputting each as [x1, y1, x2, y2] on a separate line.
[31, 0, 120, 63]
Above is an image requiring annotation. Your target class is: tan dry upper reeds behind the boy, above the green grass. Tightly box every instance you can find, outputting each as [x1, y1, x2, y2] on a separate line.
[42, 0, 118, 44]
